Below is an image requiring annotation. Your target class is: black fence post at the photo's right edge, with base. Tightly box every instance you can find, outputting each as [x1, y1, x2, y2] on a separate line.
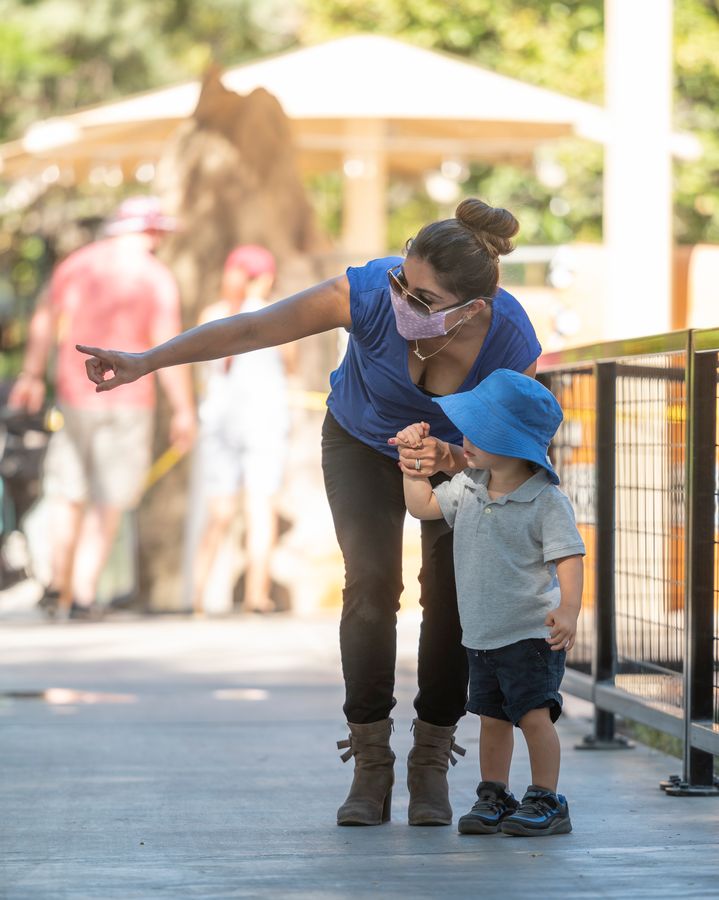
[662, 340, 719, 796]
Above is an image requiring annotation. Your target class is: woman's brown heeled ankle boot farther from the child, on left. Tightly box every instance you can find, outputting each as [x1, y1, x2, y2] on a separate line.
[337, 719, 395, 825]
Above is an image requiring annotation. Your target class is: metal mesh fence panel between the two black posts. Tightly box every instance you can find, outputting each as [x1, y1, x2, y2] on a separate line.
[615, 353, 686, 707]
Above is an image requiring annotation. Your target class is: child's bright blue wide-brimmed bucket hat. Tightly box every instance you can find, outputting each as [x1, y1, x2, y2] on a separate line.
[434, 369, 564, 484]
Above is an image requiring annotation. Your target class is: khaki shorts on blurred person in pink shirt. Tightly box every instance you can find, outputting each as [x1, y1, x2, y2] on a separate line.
[43, 407, 154, 510]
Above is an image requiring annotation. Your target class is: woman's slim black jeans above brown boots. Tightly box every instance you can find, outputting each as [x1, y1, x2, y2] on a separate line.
[322, 413, 467, 725]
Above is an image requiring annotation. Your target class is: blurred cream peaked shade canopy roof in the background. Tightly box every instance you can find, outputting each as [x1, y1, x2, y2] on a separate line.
[0, 35, 693, 180]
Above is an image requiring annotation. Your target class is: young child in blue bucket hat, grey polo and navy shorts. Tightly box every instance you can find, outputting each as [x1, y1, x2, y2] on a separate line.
[392, 369, 585, 835]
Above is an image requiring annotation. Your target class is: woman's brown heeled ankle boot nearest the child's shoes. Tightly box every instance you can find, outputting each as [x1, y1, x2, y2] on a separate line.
[407, 719, 466, 825]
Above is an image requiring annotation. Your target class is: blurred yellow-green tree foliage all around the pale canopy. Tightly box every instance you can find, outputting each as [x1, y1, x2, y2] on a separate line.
[0, 0, 719, 377]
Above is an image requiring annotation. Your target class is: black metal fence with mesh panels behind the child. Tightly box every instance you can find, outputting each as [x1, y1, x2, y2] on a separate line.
[538, 329, 719, 794]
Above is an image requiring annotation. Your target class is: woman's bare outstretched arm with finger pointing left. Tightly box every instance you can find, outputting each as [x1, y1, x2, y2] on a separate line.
[77, 275, 351, 392]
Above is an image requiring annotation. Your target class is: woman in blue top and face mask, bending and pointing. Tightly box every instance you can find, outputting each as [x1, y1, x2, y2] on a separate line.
[78, 199, 541, 825]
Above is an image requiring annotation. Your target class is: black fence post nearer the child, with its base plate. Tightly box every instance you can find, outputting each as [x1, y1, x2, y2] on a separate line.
[576, 362, 633, 750]
